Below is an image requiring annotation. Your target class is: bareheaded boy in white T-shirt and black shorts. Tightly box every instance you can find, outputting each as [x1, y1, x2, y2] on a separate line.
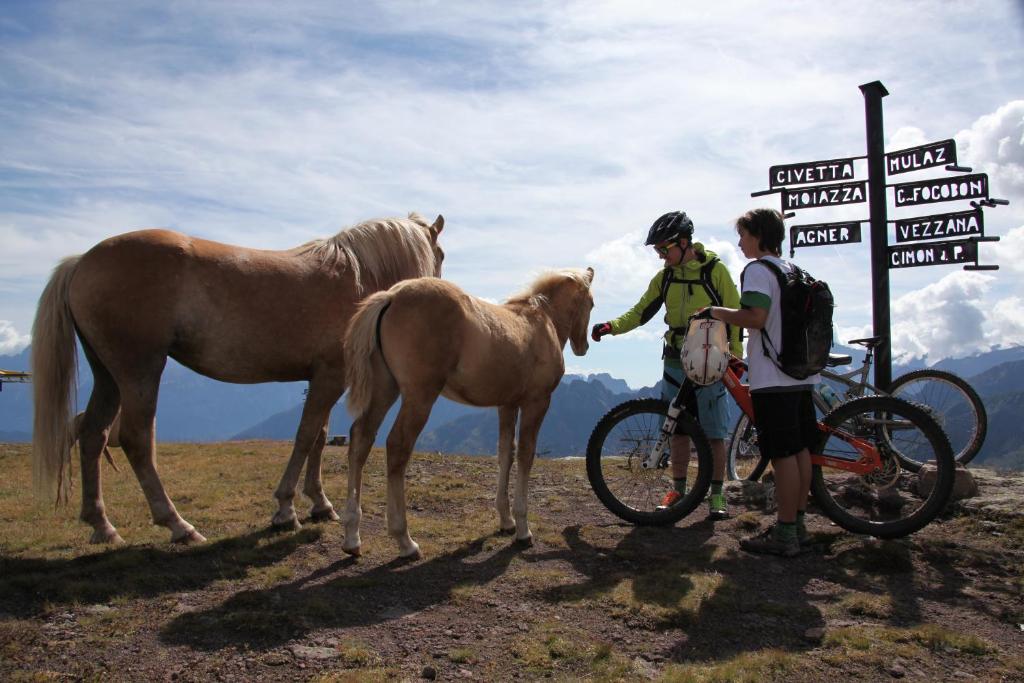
[708, 209, 820, 557]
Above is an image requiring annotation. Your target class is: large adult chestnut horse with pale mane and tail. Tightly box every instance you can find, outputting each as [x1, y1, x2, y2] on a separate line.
[32, 214, 444, 543]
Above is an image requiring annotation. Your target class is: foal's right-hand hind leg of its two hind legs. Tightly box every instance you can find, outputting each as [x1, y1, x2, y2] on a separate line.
[387, 389, 440, 558]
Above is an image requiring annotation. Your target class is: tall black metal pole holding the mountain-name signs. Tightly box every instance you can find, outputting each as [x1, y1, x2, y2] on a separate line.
[860, 81, 893, 391]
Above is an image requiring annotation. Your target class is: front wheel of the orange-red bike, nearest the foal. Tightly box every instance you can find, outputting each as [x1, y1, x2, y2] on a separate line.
[587, 398, 712, 525]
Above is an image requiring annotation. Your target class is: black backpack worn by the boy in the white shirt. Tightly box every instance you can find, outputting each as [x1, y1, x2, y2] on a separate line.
[739, 259, 836, 380]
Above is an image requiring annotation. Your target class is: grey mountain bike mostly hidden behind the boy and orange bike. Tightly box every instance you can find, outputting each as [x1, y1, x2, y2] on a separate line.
[726, 337, 988, 481]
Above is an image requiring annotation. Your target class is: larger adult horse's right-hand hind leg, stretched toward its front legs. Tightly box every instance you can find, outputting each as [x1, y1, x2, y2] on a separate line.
[120, 373, 206, 544]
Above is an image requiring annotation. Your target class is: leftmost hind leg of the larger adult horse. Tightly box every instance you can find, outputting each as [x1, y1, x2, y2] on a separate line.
[75, 347, 124, 543]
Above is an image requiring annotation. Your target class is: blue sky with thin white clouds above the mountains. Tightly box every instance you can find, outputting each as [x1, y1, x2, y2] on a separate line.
[0, 0, 1024, 387]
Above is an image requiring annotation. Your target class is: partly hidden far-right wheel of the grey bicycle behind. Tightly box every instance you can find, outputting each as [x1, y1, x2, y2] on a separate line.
[889, 370, 988, 465]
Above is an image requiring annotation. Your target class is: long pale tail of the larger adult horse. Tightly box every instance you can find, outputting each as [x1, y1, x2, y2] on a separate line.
[32, 256, 81, 504]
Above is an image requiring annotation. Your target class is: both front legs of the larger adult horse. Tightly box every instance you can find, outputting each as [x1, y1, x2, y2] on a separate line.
[270, 373, 345, 529]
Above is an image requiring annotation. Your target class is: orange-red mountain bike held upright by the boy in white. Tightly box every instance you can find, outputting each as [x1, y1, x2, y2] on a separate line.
[587, 358, 956, 539]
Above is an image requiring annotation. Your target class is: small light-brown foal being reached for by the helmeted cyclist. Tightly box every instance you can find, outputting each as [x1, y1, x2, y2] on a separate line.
[342, 268, 594, 557]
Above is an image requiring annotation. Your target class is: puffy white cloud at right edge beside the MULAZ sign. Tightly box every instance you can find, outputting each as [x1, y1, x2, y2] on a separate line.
[956, 99, 1024, 201]
